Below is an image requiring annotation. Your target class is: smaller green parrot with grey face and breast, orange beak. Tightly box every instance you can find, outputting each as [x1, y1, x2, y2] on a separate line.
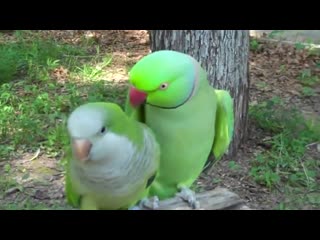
[65, 102, 160, 210]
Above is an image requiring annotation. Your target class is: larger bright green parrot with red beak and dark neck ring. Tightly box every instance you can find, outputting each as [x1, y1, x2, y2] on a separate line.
[125, 50, 234, 208]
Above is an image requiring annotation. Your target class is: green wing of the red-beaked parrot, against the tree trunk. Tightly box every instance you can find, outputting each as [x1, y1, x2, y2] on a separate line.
[213, 89, 234, 159]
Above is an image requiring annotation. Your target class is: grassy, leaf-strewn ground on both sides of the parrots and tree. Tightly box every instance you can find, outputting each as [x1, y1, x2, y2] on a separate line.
[0, 31, 320, 209]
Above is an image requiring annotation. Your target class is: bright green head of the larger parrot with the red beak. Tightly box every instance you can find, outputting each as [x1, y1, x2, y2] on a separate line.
[129, 50, 199, 108]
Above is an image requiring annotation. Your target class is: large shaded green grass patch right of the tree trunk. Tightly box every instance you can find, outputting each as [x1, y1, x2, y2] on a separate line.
[249, 97, 320, 201]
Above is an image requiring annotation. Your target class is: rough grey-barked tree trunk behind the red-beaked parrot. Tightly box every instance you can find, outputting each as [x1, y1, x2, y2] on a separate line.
[149, 30, 249, 158]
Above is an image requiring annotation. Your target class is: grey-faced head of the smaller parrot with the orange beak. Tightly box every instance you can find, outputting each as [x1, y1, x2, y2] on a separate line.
[67, 102, 131, 163]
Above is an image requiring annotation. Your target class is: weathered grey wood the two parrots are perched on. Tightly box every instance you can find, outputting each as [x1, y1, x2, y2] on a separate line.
[136, 188, 251, 210]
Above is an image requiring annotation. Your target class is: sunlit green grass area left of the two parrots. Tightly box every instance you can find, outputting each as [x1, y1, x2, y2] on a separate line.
[0, 31, 125, 161]
